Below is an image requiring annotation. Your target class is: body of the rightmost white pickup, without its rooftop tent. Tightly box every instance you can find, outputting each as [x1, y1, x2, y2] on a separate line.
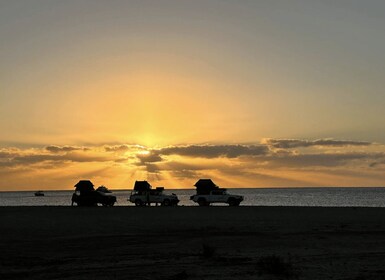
[190, 189, 243, 206]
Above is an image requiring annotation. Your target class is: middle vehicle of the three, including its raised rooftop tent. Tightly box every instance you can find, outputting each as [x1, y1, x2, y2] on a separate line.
[128, 181, 179, 206]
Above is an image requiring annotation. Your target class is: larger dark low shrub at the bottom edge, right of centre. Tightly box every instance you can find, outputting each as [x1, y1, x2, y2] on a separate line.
[257, 255, 298, 279]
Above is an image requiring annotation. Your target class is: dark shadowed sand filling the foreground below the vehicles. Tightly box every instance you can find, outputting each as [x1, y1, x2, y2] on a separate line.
[0, 207, 385, 280]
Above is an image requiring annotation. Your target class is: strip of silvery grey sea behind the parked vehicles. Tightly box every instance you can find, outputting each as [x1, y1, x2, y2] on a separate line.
[0, 187, 385, 207]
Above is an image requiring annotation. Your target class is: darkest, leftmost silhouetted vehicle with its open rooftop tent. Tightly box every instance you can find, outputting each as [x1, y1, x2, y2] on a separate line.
[72, 180, 116, 206]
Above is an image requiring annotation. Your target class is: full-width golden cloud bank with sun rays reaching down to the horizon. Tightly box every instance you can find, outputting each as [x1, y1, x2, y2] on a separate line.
[0, 139, 385, 189]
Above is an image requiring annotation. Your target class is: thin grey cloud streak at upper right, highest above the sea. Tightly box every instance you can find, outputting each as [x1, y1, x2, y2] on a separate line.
[265, 139, 372, 149]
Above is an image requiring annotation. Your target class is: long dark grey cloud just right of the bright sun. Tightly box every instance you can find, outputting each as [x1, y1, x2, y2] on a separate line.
[156, 145, 269, 158]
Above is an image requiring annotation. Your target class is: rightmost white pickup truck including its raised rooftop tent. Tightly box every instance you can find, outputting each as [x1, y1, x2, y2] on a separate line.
[190, 179, 243, 206]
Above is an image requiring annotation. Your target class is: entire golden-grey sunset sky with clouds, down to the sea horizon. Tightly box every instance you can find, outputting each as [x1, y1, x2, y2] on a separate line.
[0, 0, 385, 190]
